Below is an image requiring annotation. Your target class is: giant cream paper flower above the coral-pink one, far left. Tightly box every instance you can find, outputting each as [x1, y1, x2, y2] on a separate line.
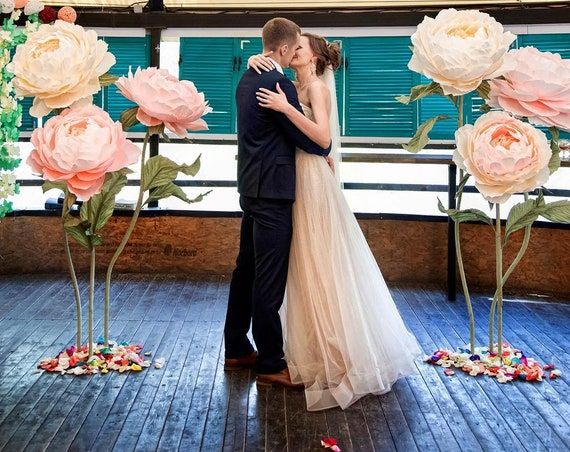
[11, 20, 115, 117]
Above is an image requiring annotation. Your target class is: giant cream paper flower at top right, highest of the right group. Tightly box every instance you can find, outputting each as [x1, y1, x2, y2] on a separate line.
[408, 8, 516, 96]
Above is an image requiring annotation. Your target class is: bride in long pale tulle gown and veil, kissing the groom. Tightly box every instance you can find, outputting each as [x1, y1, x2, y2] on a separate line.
[249, 33, 420, 411]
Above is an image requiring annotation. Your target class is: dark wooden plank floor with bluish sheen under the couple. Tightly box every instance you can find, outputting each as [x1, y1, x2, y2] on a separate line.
[0, 275, 570, 451]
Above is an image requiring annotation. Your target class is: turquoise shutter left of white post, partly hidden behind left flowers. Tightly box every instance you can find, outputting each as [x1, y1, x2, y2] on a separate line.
[102, 36, 150, 132]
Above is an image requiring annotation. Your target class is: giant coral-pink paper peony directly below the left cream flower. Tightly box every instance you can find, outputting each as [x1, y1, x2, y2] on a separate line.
[28, 105, 141, 201]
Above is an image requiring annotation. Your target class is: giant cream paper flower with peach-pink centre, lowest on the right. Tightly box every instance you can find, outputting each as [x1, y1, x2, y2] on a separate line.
[453, 111, 552, 203]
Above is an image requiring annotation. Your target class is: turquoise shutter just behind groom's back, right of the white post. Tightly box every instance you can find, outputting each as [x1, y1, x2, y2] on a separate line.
[180, 38, 235, 133]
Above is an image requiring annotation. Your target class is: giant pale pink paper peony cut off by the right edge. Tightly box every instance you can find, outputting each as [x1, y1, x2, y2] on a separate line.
[489, 47, 570, 131]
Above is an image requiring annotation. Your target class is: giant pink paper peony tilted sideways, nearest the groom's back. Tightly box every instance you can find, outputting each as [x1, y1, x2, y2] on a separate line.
[115, 67, 212, 138]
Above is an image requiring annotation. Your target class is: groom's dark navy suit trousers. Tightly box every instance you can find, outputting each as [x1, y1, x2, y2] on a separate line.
[224, 196, 293, 374]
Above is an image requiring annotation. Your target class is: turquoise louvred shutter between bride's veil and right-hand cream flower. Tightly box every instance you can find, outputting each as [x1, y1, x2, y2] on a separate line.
[345, 36, 419, 137]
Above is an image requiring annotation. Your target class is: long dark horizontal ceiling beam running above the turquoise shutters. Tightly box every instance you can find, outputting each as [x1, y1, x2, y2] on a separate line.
[72, 3, 570, 28]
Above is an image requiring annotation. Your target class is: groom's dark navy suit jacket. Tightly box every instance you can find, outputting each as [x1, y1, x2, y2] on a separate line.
[236, 69, 331, 200]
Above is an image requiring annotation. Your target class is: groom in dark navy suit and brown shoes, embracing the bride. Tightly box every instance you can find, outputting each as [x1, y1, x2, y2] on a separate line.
[224, 18, 330, 387]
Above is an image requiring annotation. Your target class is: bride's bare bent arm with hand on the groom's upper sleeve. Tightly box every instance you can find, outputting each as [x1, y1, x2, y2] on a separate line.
[257, 83, 331, 148]
